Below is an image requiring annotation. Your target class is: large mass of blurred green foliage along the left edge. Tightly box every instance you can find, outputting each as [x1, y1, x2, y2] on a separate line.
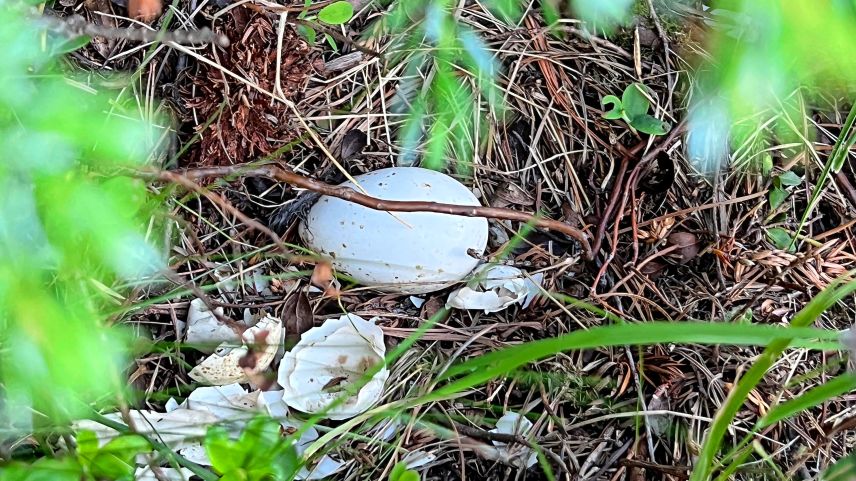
[0, 0, 163, 441]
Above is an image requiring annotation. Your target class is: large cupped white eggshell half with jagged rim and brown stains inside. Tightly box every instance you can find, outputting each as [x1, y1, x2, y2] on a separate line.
[278, 314, 389, 419]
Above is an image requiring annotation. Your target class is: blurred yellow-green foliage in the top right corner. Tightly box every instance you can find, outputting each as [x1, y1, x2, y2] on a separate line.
[688, 0, 856, 173]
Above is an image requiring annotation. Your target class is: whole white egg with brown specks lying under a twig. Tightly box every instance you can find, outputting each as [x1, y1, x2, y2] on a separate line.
[300, 167, 488, 294]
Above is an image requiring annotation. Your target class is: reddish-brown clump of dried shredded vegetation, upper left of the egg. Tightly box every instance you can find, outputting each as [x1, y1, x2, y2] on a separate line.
[182, 7, 323, 166]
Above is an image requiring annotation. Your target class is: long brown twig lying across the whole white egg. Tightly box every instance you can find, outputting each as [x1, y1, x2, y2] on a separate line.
[157, 164, 592, 259]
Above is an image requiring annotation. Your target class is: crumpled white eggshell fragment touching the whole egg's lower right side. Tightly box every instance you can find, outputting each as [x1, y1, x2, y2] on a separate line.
[446, 264, 544, 314]
